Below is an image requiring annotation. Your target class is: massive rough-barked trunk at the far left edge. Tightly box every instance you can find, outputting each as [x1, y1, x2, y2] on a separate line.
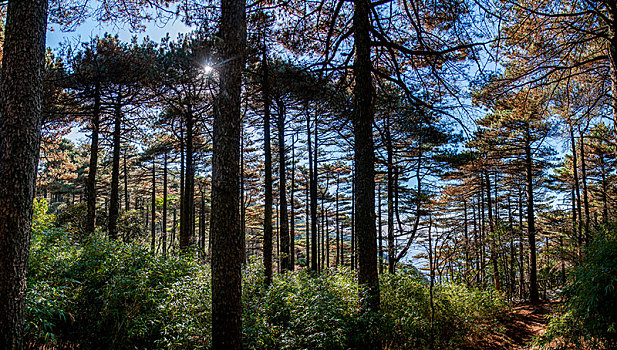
[0, 0, 47, 349]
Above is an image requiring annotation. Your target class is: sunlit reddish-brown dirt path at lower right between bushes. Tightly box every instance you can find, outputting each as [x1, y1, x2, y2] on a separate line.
[482, 301, 558, 350]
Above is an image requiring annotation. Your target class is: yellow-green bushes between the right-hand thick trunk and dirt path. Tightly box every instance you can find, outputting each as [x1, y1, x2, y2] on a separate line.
[381, 272, 506, 349]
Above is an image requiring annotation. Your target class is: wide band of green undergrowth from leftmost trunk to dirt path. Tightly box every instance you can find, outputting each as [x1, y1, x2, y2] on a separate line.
[26, 220, 504, 349]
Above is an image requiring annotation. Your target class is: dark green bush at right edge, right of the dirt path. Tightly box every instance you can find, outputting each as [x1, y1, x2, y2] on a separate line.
[538, 227, 617, 348]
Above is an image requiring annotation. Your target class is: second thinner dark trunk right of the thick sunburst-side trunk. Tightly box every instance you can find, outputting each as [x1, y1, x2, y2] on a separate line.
[277, 102, 293, 272]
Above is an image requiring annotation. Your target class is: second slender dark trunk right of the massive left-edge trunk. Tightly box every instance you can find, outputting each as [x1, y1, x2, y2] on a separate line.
[108, 90, 122, 240]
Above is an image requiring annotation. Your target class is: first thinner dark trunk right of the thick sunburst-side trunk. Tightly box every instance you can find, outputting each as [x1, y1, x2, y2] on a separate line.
[262, 49, 273, 285]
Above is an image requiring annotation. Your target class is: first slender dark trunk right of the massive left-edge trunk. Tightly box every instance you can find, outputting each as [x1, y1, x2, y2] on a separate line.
[86, 82, 101, 234]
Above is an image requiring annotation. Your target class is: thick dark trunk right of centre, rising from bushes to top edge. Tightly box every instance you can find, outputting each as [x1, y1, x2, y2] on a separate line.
[353, 0, 379, 314]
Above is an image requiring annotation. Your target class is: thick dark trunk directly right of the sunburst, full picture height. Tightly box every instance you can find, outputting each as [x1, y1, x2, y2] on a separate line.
[211, 0, 246, 350]
